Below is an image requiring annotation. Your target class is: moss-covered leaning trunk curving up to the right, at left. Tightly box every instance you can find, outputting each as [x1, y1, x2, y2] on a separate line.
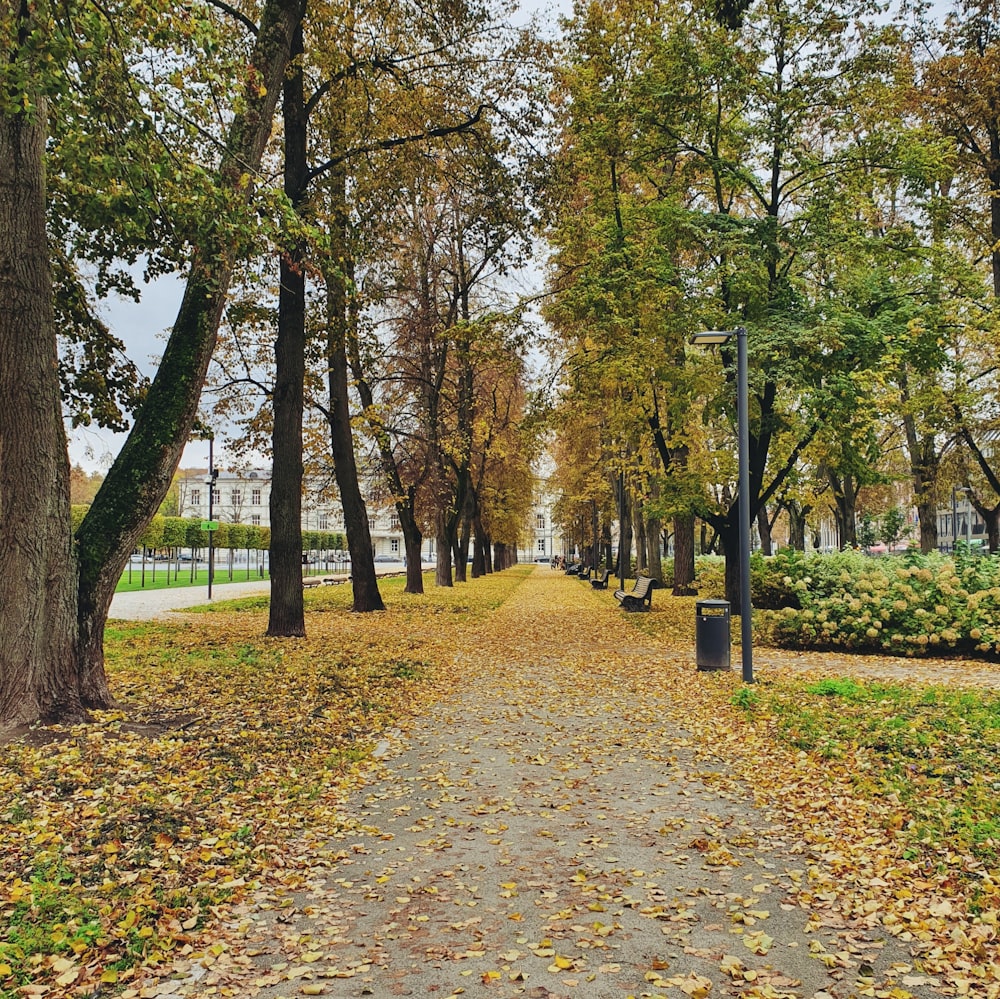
[77, 0, 304, 720]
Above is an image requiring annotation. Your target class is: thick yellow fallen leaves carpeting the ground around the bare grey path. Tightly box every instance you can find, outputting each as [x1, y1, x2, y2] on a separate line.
[0, 567, 1000, 999]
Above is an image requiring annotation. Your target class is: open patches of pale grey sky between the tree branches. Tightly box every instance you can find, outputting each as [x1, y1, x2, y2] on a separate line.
[67, 0, 572, 472]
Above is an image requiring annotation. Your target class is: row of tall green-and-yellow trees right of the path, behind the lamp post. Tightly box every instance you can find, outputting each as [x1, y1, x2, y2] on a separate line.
[546, 0, 1000, 605]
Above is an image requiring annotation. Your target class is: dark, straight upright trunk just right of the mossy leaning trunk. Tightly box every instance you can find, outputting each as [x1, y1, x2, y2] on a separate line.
[267, 25, 309, 637]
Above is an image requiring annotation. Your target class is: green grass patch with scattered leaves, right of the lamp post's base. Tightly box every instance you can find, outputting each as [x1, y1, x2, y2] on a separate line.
[736, 679, 1000, 862]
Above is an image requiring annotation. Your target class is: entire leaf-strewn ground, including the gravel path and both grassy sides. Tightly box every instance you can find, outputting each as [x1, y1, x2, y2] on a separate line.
[0, 568, 1000, 999]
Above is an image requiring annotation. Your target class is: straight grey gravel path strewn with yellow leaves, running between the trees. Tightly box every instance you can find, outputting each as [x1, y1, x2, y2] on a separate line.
[152, 573, 948, 999]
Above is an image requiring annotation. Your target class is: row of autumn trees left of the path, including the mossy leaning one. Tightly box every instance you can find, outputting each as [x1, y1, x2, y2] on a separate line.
[0, 0, 544, 728]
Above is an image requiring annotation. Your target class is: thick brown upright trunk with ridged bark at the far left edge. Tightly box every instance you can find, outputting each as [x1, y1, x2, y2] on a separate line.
[0, 100, 84, 729]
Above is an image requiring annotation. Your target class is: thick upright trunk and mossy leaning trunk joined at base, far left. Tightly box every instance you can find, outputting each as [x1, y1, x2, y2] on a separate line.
[0, 0, 301, 726]
